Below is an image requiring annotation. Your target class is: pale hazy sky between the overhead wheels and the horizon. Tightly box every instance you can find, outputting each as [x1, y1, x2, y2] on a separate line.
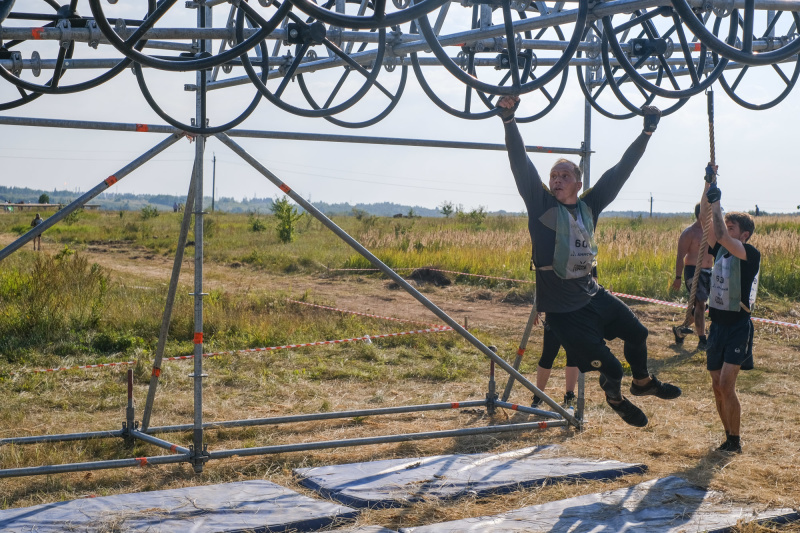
[0, 4, 800, 213]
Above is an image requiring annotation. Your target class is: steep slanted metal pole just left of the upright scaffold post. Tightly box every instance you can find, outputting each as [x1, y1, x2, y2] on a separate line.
[142, 163, 197, 433]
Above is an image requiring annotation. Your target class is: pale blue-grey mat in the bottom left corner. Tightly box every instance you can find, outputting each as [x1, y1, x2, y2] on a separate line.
[0, 480, 358, 533]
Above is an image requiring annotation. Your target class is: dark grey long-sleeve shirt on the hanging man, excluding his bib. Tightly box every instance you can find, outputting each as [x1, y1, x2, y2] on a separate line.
[505, 121, 650, 313]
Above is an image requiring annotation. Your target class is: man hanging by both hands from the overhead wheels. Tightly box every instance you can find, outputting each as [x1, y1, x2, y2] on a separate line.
[497, 96, 681, 427]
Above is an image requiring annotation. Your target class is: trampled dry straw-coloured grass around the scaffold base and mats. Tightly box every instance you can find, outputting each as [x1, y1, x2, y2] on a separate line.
[0, 228, 800, 533]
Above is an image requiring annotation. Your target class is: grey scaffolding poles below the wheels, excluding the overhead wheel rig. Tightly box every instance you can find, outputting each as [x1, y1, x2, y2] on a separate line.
[0, 108, 591, 478]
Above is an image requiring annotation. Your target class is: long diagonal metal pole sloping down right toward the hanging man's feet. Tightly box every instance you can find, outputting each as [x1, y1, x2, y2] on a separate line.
[216, 133, 581, 428]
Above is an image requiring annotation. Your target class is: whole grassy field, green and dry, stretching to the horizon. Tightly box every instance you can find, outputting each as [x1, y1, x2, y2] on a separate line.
[0, 212, 800, 531]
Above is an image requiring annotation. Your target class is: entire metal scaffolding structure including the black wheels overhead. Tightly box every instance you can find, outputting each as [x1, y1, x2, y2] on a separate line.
[0, 0, 800, 478]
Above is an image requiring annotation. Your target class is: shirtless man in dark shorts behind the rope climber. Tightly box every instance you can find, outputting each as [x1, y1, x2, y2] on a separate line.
[672, 204, 714, 350]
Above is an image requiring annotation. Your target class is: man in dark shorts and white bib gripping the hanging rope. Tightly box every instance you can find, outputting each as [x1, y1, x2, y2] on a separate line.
[703, 175, 761, 453]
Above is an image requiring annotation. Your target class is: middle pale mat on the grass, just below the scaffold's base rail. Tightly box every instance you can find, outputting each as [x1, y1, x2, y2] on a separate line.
[294, 446, 647, 508]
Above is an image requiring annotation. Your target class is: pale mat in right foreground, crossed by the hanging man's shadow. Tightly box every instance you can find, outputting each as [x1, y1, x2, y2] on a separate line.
[400, 476, 798, 533]
